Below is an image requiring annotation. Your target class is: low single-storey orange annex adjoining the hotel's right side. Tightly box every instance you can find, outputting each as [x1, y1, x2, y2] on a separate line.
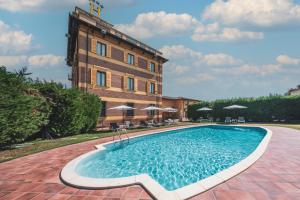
[162, 96, 200, 121]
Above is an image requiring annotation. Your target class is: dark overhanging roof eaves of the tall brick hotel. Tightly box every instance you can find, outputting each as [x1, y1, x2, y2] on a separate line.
[67, 7, 168, 65]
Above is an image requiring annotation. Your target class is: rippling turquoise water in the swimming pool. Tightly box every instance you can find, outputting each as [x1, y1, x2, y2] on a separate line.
[76, 126, 266, 190]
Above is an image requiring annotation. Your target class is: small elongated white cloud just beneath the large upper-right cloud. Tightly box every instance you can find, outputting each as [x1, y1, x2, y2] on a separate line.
[192, 23, 264, 42]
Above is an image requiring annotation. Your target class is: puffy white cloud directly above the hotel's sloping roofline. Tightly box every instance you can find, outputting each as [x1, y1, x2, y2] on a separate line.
[116, 11, 199, 39]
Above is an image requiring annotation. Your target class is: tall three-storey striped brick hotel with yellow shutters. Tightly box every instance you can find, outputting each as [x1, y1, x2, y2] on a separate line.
[67, 8, 167, 126]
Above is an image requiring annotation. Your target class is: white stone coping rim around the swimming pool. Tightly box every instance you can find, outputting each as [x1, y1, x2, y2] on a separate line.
[60, 124, 272, 200]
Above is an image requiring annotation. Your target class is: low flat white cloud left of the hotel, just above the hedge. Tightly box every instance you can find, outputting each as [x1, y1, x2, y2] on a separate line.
[0, 54, 65, 68]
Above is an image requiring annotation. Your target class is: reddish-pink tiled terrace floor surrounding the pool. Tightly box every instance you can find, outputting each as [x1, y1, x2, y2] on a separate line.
[0, 127, 300, 200]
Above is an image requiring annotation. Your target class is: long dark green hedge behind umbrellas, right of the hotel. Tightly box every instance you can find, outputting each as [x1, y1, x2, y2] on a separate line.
[188, 95, 300, 122]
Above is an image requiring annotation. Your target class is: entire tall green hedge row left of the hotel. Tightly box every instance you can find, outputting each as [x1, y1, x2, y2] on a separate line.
[0, 67, 101, 147]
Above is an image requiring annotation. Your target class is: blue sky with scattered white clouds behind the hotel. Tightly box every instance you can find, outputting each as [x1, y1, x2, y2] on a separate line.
[0, 0, 300, 100]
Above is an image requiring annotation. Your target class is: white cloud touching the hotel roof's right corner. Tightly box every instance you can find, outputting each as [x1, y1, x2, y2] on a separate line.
[160, 45, 241, 66]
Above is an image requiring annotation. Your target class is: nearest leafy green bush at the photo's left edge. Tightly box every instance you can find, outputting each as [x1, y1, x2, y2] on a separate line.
[0, 67, 49, 147]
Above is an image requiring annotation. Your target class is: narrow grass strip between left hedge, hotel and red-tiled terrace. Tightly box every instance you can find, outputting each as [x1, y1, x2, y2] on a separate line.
[0, 123, 189, 163]
